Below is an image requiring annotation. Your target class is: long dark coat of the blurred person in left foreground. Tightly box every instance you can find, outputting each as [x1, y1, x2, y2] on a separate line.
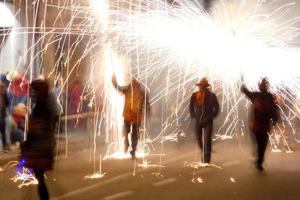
[22, 93, 59, 171]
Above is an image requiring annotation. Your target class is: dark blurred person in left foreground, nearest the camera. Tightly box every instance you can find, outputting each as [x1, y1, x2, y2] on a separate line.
[21, 79, 60, 200]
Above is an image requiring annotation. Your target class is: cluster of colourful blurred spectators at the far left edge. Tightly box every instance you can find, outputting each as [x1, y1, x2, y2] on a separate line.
[0, 71, 29, 151]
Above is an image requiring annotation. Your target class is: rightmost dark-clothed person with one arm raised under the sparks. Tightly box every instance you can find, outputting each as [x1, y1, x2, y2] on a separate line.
[241, 78, 279, 171]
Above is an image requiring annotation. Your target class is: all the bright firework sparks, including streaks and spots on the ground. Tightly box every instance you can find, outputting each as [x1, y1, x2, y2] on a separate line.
[0, 0, 300, 191]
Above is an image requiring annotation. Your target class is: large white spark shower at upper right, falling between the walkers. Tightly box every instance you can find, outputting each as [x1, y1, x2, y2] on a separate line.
[108, 0, 300, 152]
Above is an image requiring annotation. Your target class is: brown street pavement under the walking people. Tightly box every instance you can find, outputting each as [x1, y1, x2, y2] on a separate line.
[0, 135, 300, 200]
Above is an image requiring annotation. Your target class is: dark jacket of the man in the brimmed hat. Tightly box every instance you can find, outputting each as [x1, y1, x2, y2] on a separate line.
[190, 89, 219, 126]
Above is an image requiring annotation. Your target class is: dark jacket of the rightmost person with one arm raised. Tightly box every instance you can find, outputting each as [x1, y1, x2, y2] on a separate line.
[241, 87, 279, 132]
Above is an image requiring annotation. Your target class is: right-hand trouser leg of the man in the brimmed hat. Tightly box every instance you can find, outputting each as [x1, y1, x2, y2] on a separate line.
[203, 122, 213, 163]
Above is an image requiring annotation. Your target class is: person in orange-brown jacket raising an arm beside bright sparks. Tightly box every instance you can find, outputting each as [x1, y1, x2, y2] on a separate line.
[112, 75, 150, 159]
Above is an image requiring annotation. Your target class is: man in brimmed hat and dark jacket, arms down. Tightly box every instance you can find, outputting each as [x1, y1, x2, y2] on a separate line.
[190, 78, 219, 164]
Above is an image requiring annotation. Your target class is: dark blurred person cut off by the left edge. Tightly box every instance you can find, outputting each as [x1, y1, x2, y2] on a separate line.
[0, 81, 8, 151]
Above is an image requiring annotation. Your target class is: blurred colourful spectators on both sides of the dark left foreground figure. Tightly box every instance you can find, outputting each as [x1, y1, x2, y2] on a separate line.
[0, 71, 92, 153]
